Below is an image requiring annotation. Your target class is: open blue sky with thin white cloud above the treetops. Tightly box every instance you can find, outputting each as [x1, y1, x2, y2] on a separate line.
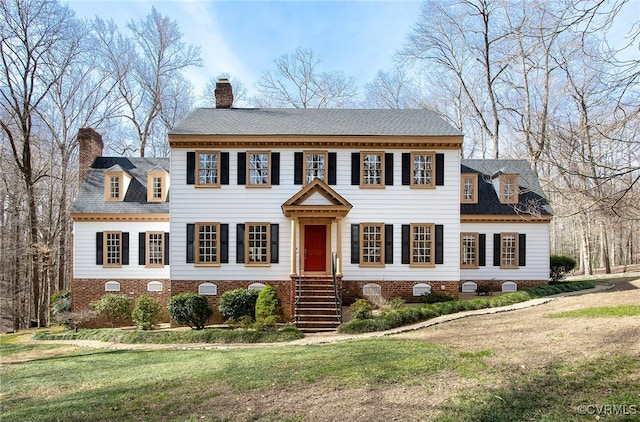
[69, 0, 421, 95]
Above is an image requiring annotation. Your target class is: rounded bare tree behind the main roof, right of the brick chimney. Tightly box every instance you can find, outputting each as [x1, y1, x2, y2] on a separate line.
[256, 47, 357, 108]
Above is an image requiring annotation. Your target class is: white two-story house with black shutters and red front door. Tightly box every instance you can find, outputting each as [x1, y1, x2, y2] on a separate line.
[69, 80, 551, 330]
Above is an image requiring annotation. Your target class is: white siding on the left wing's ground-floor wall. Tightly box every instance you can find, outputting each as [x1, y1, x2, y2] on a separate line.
[73, 221, 173, 280]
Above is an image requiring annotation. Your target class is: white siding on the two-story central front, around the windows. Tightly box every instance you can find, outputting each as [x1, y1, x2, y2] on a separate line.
[170, 148, 460, 280]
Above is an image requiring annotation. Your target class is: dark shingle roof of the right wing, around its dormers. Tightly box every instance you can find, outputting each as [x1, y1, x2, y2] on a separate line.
[460, 160, 553, 216]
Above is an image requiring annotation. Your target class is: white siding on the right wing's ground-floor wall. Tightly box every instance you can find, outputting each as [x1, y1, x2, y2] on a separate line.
[460, 223, 550, 281]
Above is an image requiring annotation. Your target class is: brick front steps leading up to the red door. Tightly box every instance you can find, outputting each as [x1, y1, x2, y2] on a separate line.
[295, 277, 342, 333]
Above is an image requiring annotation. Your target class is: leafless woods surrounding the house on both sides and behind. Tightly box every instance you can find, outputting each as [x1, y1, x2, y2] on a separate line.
[0, 0, 640, 331]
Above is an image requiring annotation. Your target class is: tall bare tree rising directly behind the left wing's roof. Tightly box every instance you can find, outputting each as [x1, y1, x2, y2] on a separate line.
[94, 8, 202, 157]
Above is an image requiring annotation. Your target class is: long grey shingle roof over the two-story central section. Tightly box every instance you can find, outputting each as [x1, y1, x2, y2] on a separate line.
[169, 108, 462, 136]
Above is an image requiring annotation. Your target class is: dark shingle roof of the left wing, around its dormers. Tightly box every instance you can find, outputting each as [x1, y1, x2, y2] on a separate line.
[71, 157, 169, 214]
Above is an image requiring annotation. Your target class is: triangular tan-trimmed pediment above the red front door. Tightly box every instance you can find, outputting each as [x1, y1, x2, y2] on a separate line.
[282, 179, 353, 218]
